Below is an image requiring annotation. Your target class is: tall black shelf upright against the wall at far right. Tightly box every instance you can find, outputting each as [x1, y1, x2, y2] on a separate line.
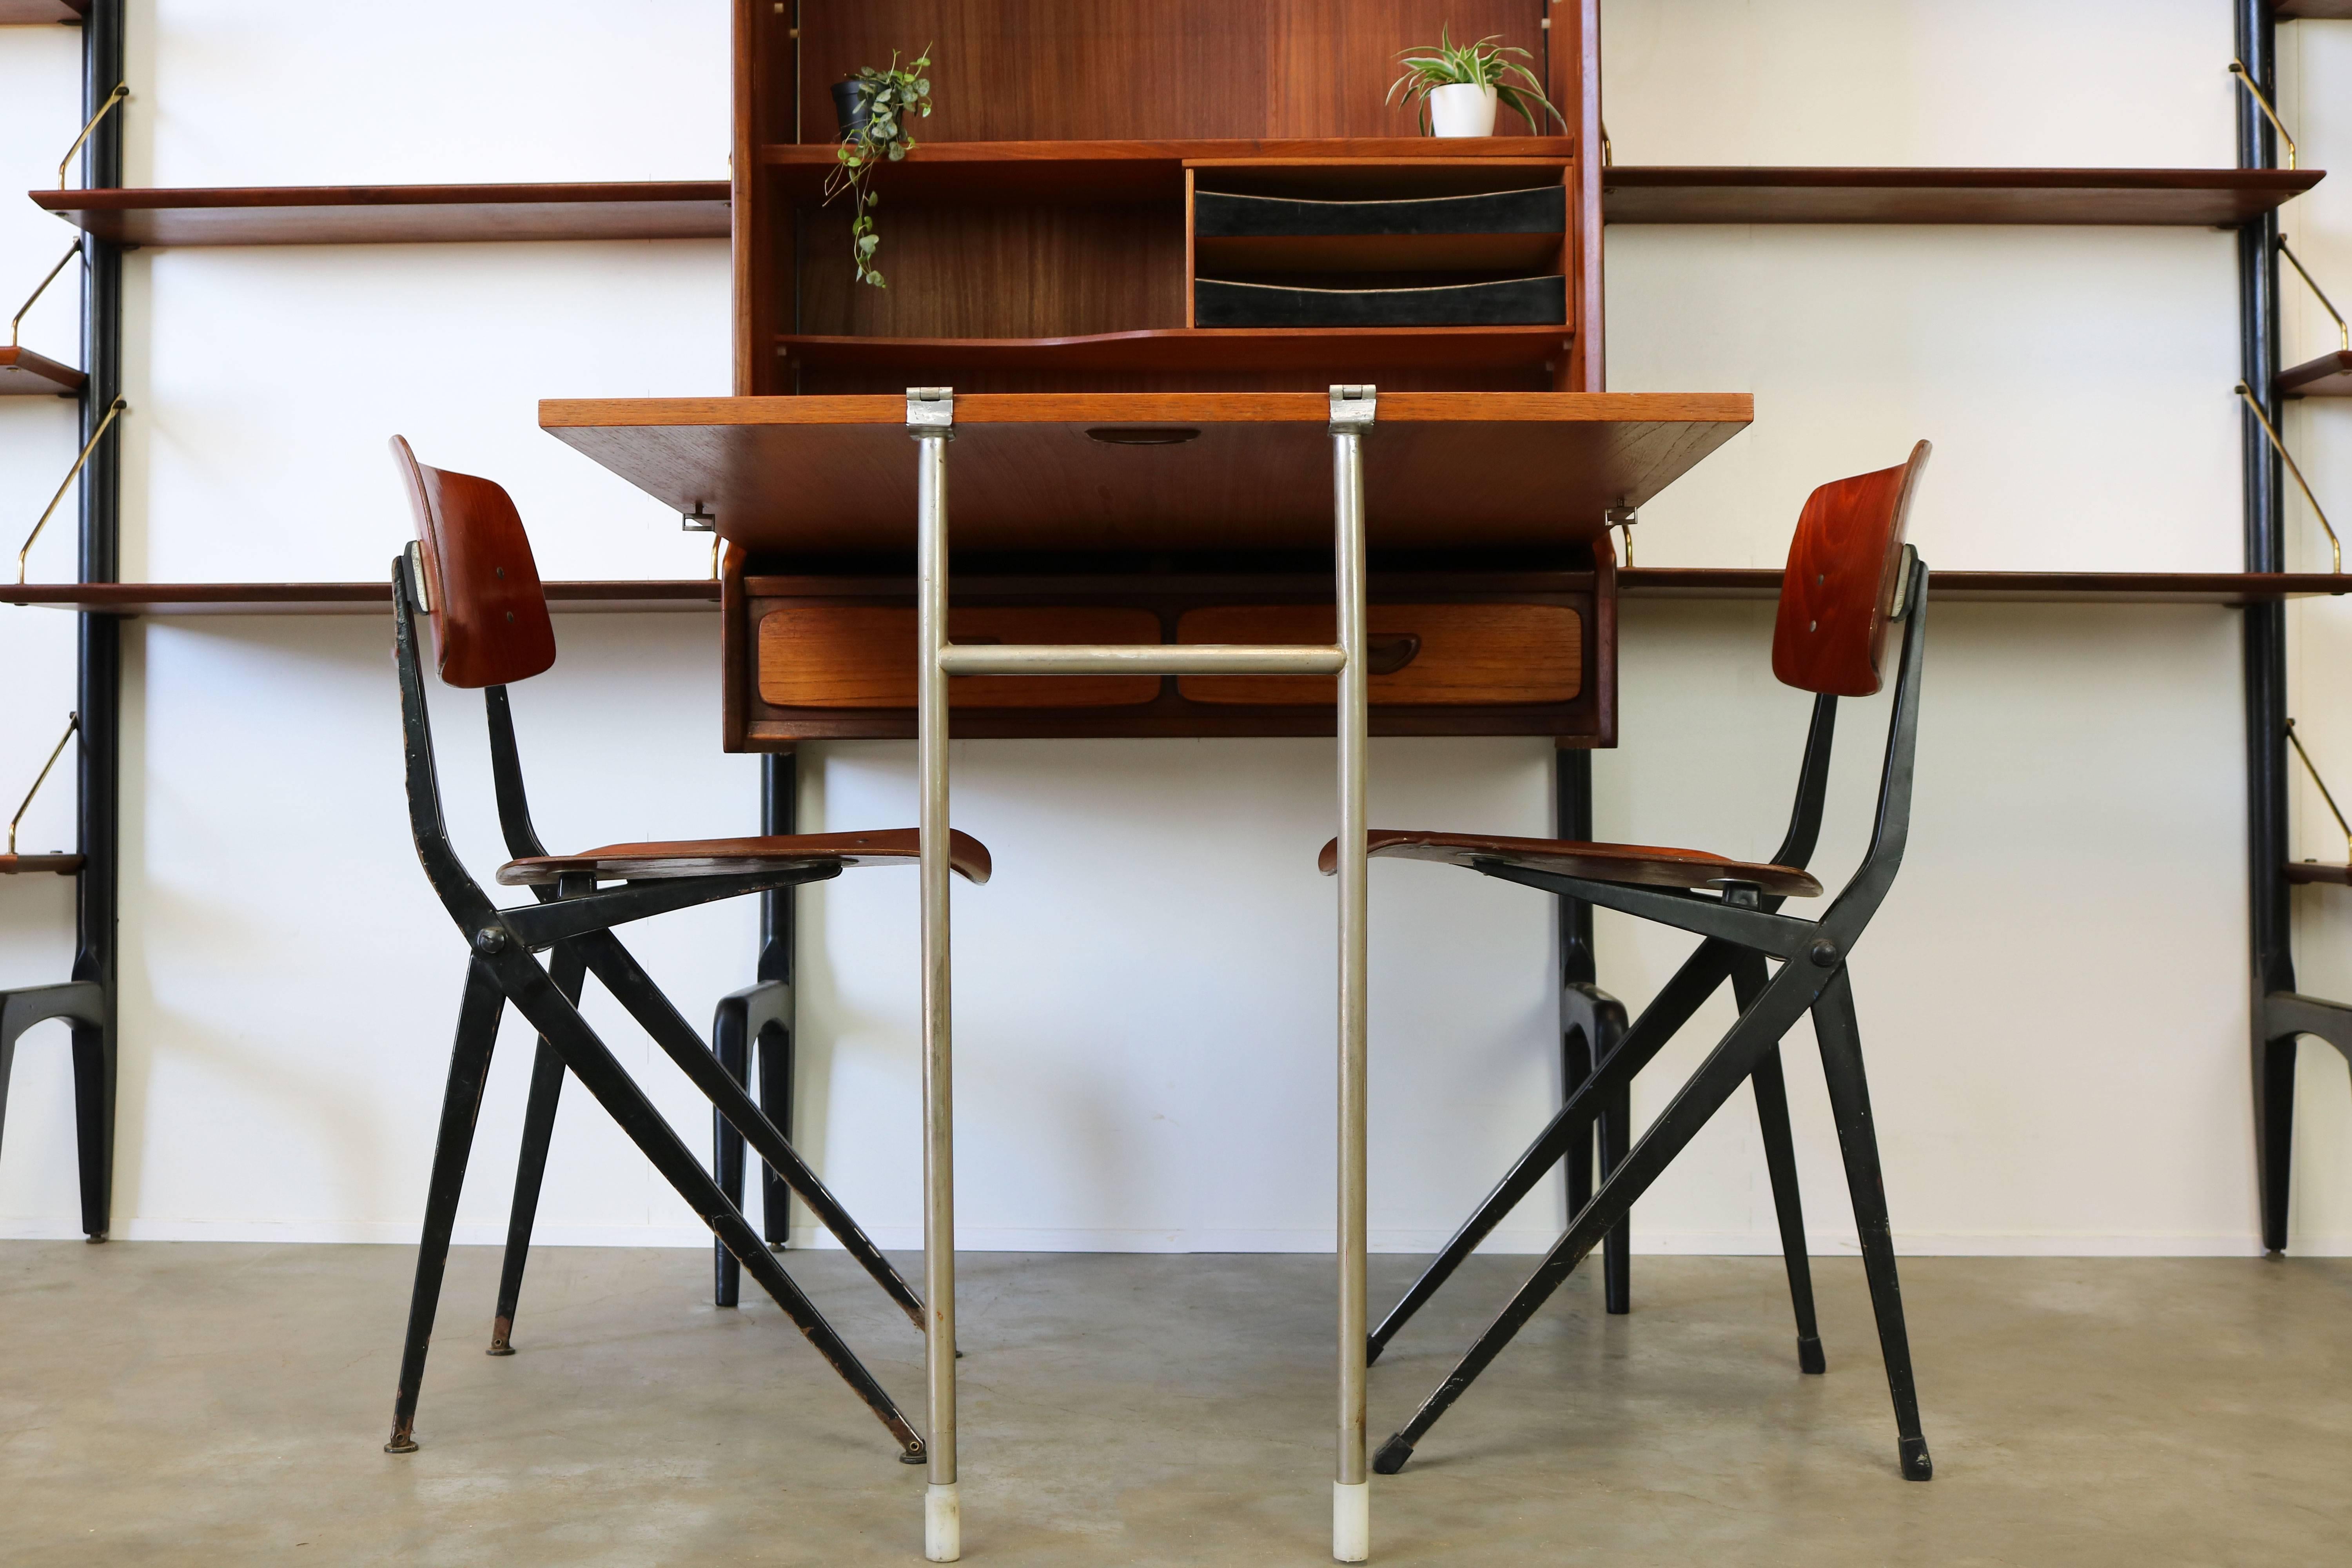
[2234, 0, 2296, 1250]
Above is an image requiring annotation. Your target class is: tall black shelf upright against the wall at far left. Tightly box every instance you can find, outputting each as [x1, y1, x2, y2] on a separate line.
[73, 0, 125, 1239]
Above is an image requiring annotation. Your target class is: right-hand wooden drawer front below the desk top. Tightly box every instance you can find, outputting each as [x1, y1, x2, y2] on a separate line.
[1176, 604, 1585, 708]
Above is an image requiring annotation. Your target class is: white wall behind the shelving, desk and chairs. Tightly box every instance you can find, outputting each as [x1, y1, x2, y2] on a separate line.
[0, 0, 2352, 1253]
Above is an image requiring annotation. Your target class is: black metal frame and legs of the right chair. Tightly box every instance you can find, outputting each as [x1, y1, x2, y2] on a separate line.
[1371, 545, 1933, 1481]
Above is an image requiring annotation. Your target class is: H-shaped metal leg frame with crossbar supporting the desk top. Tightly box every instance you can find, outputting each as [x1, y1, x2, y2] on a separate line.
[906, 386, 1376, 1563]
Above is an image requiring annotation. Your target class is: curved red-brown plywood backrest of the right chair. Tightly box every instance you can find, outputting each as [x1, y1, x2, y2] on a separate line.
[1771, 442, 1929, 696]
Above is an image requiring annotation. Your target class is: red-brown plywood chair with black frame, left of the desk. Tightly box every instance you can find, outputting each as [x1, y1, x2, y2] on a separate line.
[386, 437, 990, 1465]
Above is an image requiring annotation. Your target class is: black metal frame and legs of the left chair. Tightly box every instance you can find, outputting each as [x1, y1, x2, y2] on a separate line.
[383, 555, 924, 1465]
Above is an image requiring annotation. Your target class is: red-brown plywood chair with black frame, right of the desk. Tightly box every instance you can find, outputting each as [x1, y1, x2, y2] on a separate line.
[1324, 442, 1933, 1481]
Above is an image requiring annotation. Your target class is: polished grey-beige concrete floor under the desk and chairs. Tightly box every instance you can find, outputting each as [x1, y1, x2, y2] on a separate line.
[0, 1241, 2352, 1568]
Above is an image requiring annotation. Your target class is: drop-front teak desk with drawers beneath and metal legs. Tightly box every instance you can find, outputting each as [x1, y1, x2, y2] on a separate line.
[541, 386, 1752, 1561]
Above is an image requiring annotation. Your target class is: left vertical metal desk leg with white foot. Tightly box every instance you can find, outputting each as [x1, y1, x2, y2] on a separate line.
[906, 388, 962, 1563]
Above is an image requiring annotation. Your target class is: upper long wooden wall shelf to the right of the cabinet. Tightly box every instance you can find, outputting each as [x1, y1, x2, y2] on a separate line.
[1602, 167, 2326, 228]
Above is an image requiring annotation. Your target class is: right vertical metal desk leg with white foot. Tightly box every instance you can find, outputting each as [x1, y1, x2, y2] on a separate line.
[1331, 386, 1371, 1563]
